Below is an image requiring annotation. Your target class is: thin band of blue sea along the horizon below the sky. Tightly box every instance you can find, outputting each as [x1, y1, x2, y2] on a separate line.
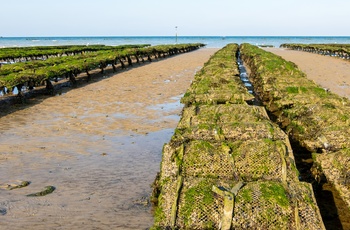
[0, 36, 350, 48]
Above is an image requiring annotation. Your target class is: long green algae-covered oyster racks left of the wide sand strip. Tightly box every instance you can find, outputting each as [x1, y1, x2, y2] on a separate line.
[0, 43, 204, 96]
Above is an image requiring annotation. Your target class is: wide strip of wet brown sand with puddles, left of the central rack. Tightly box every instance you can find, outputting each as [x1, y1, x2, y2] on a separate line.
[0, 48, 217, 229]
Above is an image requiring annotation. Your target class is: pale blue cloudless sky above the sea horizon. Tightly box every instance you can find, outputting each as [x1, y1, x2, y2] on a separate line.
[0, 0, 350, 37]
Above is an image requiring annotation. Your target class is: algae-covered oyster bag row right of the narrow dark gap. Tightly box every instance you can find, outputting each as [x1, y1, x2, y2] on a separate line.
[240, 44, 350, 225]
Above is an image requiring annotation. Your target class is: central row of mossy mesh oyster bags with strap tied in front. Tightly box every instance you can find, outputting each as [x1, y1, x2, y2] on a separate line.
[153, 44, 324, 229]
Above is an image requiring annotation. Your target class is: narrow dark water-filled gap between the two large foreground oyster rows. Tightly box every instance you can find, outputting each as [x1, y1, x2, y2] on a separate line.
[237, 52, 350, 230]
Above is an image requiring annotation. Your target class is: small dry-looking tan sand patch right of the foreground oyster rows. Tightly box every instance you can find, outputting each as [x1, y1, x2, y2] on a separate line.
[265, 48, 350, 99]
